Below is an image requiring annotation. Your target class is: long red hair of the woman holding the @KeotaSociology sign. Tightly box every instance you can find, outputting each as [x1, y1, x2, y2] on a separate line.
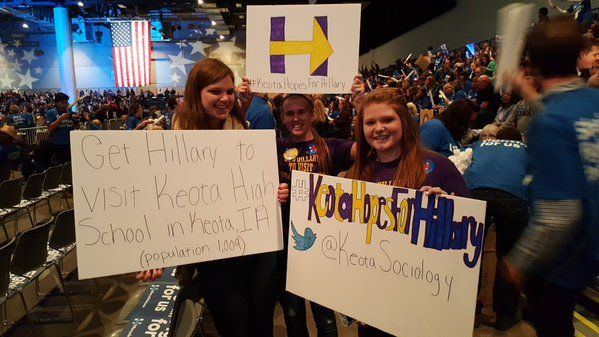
[347, 88, 426, 188]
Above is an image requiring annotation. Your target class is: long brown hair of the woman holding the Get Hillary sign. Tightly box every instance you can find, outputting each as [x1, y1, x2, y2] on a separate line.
[173, 58, 246, 130]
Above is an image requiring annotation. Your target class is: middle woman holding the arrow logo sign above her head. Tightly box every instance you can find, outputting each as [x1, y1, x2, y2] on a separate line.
[277, 94, 356, 337]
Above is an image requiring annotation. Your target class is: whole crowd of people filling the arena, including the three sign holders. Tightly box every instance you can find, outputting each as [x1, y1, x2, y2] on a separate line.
[0, 9, 599, 337]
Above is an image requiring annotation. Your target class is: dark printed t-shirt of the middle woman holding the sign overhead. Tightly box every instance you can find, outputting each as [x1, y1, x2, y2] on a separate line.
[277, 138, 354, 183]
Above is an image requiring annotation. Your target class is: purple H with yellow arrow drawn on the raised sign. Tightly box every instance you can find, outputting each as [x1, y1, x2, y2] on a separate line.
[270, 16, 333, 76]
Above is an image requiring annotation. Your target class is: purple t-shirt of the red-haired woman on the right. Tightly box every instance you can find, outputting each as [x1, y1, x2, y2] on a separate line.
[370, 151, 470, 198]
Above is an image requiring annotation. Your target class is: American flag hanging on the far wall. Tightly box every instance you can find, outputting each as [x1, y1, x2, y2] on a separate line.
[110, 21, 150, 87]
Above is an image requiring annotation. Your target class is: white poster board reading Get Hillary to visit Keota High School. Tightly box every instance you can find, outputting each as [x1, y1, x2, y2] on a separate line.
[71, 130, 283, 279]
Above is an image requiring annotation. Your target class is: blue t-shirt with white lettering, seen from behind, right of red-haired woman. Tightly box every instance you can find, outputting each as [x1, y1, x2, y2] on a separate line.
[464, 139, 527, 200]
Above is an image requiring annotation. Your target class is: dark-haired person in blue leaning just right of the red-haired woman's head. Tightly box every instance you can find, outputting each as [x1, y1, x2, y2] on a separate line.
[420, 100, 474, 157]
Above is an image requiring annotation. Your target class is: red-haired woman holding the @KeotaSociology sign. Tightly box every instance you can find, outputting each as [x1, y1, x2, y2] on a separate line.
[346, 85, 468, 337]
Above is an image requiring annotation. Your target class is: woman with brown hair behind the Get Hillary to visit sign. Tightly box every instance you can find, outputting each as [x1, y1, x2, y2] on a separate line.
[141, 58, 276, 337]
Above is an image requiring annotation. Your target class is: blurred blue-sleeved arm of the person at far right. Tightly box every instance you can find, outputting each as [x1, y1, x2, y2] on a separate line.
[507, 114, 588, 274]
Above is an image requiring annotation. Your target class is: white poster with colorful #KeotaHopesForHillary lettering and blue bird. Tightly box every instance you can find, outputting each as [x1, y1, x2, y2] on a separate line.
[287, 171, 485, 337]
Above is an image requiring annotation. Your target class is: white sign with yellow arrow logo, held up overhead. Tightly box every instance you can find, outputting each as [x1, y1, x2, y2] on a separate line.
[246, 4, 360, 94]
